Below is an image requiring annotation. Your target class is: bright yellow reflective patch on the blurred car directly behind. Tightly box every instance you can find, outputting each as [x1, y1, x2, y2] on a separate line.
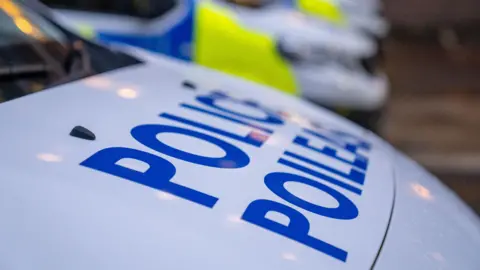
[193, 1, 297, 94]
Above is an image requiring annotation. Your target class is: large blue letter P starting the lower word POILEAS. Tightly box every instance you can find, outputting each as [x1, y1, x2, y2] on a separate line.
[242, 200, 348, 262]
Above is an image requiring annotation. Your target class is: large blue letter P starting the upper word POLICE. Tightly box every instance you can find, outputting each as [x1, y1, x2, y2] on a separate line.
[80, 147, 218, 208]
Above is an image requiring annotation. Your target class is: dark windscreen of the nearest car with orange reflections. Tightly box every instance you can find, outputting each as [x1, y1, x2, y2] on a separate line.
[0, 0, 140, 102]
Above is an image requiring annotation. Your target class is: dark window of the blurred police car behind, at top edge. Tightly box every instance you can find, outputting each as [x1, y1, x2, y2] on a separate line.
[42, 0, 179, 18]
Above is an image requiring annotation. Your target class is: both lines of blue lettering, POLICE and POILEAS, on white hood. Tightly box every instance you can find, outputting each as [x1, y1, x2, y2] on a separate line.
[80, 92, 371, 262]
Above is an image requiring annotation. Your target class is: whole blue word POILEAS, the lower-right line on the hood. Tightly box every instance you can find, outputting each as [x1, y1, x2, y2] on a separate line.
[242, 125, 371, 262]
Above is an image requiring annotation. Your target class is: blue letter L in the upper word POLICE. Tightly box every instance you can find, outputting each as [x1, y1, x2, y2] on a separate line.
[160, 113, 268, 147]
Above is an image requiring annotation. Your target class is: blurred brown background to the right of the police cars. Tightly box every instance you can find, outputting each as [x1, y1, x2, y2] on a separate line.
[383, 0, 480, 213]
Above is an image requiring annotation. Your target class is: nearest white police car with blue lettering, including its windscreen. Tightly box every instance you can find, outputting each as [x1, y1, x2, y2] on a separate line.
[0, 0, 480, 270]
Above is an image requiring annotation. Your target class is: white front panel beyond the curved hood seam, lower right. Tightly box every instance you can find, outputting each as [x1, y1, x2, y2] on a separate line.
[375, 150, 480, 270]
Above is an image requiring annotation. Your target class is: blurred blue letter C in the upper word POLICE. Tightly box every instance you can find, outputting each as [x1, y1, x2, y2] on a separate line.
[197, 94, 283, 125]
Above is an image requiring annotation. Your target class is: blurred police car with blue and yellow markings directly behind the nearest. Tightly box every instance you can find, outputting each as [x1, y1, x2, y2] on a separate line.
[39, 0, 388, 129]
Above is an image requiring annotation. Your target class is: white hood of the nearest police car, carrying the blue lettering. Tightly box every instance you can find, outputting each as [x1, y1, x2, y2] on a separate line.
[0, 53, 393, 270]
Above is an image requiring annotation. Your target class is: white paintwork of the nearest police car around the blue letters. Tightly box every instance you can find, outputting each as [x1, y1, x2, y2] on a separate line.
[0, 42, 480, 270]
